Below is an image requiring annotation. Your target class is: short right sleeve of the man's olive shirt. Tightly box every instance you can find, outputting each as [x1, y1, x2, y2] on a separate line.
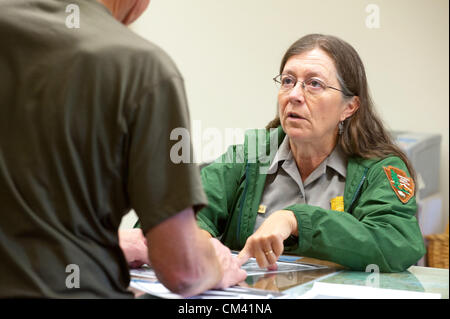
[127, 76, 207, 234]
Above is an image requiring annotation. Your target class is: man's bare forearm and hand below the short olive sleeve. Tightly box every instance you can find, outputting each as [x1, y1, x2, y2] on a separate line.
[146, 208, 246, 297]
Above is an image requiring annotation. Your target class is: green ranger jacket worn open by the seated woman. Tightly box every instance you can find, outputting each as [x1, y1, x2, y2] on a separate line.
[197, 126, 425, 272]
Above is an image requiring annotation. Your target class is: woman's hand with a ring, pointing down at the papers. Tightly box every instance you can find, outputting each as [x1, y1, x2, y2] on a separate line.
[238, 210, 298, 270]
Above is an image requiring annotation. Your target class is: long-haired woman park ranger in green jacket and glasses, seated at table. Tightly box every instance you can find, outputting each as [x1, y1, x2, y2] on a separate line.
[197, 34, 425, 272]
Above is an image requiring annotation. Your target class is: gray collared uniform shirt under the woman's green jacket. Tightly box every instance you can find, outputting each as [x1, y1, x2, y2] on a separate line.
[254, 135, 347, 231]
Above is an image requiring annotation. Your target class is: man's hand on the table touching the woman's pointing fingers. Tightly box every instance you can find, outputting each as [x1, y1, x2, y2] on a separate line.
[210, 238, 247, 289]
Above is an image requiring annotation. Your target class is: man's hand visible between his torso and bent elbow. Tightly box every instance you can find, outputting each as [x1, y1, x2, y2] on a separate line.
[119, 228, 150, 268]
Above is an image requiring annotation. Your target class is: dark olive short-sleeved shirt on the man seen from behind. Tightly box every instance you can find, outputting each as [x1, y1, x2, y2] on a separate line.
[0, 0, 207, 298]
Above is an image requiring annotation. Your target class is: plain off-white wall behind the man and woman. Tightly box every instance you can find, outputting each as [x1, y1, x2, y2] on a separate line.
[118, 0, 449, 230]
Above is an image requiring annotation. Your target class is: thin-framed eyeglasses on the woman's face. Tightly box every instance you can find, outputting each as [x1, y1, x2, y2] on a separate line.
[273, 74, 353, 96]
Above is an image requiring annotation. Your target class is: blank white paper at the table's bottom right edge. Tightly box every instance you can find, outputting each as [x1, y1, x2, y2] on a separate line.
[297, 282, 441, 299]
